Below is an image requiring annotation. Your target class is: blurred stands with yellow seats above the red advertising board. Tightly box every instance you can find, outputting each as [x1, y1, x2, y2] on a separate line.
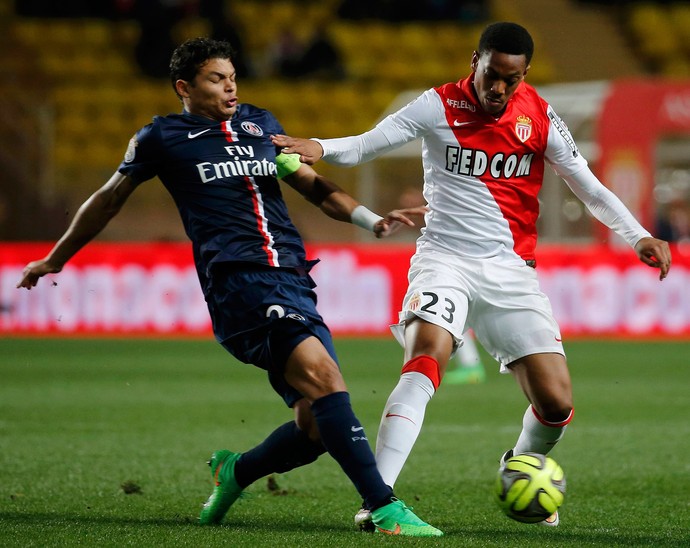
[0, 0, 690, 242]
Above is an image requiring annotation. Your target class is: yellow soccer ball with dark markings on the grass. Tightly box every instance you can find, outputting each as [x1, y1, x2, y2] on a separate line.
[495, 453, 565, 523]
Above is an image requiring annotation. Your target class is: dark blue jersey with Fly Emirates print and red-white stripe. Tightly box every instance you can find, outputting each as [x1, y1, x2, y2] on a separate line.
[119, 104, 306, 277]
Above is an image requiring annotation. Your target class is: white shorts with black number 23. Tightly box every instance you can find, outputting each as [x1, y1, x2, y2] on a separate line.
[391, 251, 565, 373]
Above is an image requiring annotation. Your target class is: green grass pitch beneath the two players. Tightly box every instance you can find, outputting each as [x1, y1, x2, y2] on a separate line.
[0, 338, 690, 548]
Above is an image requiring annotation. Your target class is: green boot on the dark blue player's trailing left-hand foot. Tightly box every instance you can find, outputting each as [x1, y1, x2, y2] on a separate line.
[199, 449, 242, 525]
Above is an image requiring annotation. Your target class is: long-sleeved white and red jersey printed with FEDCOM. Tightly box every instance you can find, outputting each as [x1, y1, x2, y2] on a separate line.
[318, 75, 649, 262]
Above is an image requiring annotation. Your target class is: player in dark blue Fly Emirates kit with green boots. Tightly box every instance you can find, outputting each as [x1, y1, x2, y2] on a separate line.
[17, 38, 442, 536]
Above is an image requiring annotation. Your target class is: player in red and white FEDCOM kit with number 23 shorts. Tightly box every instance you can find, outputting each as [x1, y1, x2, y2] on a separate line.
[273, 23, 671, 525]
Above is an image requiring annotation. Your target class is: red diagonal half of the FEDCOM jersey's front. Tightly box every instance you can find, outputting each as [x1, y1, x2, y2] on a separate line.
[436, 76, 550, 260]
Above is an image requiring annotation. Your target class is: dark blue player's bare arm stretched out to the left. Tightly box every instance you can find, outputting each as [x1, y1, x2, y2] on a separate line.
[17, 173, 136, 289]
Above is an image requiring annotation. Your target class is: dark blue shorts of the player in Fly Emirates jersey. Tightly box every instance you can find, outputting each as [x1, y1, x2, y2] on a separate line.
[204, 264, 338, 407]
